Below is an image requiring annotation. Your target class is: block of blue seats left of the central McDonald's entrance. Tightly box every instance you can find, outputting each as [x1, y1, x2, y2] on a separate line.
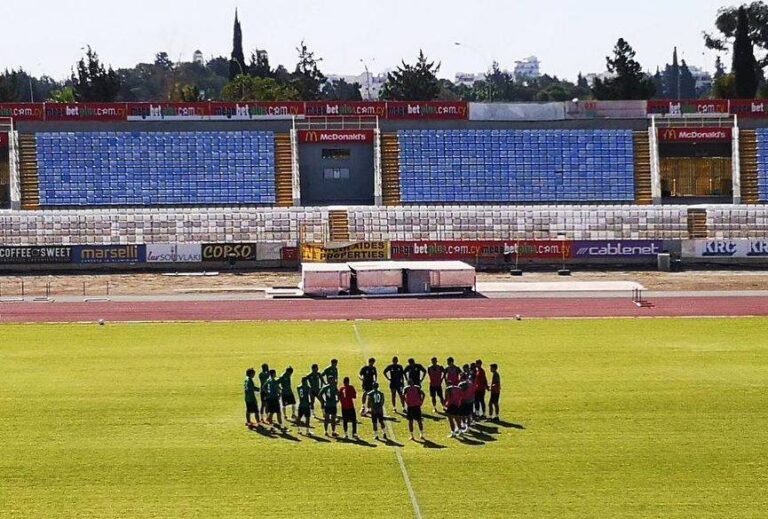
[36, 131, 276, 207]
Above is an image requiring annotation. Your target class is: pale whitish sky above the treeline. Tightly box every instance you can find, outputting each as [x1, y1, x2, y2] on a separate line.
[0, 0, 731, 79]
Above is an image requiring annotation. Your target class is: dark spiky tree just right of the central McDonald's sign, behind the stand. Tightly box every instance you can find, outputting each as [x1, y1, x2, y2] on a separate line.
[381, 50, 440, 101]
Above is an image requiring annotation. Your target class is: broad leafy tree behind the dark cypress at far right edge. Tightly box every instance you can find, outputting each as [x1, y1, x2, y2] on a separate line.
[704, 1, 768, 68]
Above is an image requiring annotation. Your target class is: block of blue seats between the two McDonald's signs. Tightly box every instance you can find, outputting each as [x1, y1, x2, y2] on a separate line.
[399, 130, 635, 203]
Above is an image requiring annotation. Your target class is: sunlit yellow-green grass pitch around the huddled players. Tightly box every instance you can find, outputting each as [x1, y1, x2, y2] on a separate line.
[0, 319, 768, 518]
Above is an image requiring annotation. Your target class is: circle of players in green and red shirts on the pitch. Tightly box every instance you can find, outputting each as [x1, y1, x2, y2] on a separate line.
[243, 357, 501, 441]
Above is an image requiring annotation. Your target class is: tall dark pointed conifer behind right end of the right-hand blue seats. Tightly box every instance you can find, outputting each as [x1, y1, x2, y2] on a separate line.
[592, 38, 655, 100]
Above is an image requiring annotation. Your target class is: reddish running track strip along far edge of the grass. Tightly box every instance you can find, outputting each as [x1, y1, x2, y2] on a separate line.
[0, 297, 768, 323]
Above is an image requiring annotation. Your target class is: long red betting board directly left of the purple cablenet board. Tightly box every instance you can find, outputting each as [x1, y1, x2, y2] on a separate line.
[391, 240, 573, 261]
